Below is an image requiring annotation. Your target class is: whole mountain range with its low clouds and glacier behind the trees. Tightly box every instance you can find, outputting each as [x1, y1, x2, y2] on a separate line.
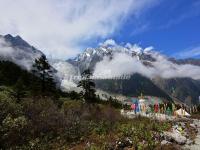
[0, 34, 200, 103]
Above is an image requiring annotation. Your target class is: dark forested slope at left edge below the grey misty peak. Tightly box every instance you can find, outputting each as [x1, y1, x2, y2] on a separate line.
[0, 61, 61, 97]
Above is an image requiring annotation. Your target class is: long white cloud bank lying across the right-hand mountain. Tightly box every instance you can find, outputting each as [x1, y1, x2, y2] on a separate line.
[94, 40, 200, 80]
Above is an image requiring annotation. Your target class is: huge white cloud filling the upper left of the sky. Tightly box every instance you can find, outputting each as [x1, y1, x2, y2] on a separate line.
[0, 0, 157, 58]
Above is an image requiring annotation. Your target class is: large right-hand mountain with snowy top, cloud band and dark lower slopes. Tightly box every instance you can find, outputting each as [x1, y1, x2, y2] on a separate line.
[67, 41, 200, 103]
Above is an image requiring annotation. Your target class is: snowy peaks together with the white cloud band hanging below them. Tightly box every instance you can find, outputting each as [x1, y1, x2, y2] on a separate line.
[68, 40, 200, 80]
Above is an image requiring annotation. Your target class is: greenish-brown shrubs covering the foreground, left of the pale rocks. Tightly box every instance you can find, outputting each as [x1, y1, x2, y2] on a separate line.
[0, 88, 173, 149]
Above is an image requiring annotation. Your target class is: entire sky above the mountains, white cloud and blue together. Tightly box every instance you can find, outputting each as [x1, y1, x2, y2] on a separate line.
[0, 0, 200, 59]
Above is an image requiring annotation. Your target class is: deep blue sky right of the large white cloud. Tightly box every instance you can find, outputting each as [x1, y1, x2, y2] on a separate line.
[93, 0, 200, 58]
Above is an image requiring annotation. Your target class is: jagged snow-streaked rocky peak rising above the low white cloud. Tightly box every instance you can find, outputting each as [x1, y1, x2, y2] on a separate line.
[67, 43, 155, 72]
